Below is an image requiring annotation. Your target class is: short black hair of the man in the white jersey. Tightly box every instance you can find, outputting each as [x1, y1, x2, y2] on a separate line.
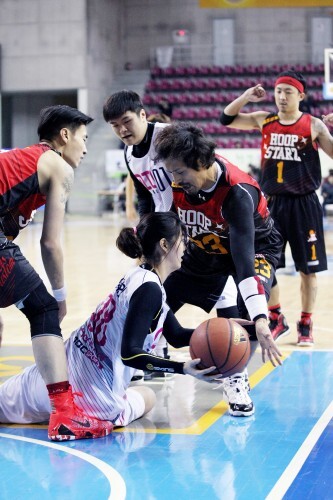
[103, 90, 144, 123]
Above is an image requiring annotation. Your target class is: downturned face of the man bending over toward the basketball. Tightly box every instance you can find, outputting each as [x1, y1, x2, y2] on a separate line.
[165, 160, 210, 194]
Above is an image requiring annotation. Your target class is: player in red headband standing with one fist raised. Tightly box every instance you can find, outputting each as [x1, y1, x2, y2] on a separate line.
[220, 70, 333, 346]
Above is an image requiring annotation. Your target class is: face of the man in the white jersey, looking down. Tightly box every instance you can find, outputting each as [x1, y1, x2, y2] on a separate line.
[109, 109, 148, 146]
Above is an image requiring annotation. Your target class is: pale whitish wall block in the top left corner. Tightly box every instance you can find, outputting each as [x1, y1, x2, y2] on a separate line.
[0, 0, 87, 92]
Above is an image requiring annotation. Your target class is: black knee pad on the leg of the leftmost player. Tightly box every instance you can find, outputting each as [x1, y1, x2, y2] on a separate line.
[21, 283, 62, 338]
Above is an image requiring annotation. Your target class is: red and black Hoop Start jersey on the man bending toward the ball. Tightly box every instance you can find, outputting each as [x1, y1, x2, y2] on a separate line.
[172, 155, 272, 255]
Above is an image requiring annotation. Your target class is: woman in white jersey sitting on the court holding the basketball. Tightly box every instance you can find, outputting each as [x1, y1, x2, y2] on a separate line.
[0, 212, 216, 426]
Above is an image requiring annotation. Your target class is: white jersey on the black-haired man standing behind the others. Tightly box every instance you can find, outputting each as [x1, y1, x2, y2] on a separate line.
[125, 123, 173, 212]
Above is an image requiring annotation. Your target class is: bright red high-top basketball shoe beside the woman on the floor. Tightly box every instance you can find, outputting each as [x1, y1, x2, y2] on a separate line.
[48, 386, 113, 441]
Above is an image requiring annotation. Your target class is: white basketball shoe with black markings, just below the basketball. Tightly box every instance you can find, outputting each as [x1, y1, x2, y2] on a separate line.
[221, 369, 254, 417]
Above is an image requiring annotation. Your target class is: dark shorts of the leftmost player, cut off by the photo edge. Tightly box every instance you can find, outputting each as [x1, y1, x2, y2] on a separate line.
[0, 232, 42, 308]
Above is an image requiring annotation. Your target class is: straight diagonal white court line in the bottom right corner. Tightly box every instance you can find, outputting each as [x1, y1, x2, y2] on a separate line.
[266, 401, 333, 500]
